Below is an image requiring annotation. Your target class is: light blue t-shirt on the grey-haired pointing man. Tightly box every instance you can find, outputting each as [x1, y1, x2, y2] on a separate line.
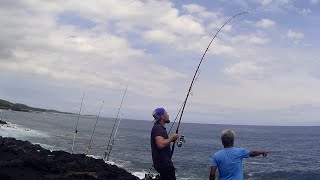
[211, 147, 250, 180]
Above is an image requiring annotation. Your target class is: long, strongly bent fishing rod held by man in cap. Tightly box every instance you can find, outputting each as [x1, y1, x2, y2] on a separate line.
[171, 12, 248, 154]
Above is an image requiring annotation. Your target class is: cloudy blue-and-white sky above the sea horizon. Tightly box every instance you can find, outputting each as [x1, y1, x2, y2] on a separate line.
[0, 0, 320, 126]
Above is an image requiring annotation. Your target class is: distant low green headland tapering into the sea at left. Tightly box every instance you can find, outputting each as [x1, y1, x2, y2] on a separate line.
[0, 99, 73, 114]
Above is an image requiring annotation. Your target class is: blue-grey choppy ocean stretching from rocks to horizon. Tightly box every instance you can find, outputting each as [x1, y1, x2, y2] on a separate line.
[0, 110, 320, 180]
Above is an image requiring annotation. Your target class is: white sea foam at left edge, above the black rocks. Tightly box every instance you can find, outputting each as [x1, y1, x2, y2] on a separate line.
[0, 122, 49, 140]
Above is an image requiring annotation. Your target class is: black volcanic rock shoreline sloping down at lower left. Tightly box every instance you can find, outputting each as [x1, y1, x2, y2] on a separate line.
[0, 136, 139, 180]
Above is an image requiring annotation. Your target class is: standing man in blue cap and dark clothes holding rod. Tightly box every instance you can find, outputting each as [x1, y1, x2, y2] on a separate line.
[151, 108, 179, 180]
